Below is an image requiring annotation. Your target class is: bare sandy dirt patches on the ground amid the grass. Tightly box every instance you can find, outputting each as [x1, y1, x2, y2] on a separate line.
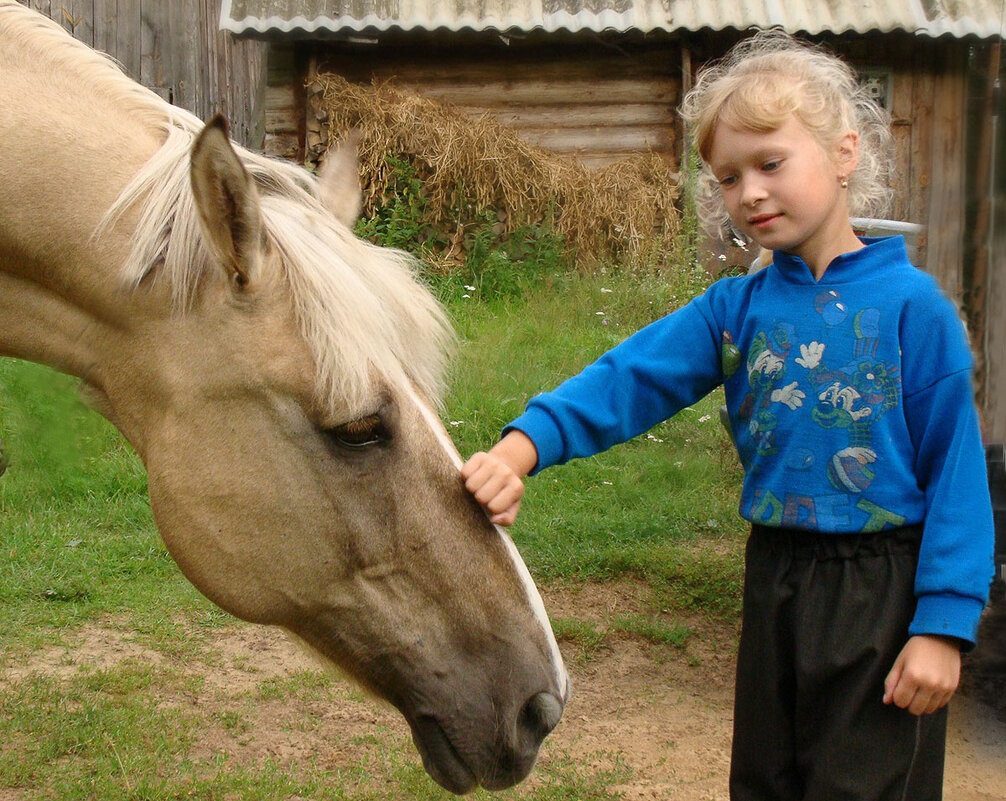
[0, 584, 1006, 801]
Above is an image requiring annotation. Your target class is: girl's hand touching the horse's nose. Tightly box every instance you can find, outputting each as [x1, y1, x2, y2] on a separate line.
[461, 431, 538, 525]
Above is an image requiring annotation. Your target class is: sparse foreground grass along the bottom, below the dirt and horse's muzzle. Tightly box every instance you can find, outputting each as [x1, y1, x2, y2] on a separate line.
[0, 660, 625, 801]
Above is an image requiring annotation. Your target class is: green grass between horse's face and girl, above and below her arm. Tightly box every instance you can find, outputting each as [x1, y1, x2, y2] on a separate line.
[440, 265, 745, 616]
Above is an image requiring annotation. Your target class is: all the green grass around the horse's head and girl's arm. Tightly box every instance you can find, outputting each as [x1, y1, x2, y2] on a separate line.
[0, 271, 744, 801]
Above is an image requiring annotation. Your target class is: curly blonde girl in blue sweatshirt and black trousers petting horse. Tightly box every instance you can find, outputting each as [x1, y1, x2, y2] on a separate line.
[462, 31, 993, 801]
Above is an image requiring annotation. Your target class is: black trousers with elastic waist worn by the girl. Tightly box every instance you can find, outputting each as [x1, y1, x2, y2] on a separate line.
[730, 525, 947, 801]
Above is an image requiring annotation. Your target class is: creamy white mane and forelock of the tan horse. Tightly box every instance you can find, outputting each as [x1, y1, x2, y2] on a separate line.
[0, 0, 454, 414]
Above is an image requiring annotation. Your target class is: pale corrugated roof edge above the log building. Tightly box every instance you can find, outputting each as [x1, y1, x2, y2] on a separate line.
[220, 0, 1006, 38]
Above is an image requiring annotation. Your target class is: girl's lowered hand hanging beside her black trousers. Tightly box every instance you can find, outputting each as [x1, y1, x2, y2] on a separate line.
[883, 634, 961, 714]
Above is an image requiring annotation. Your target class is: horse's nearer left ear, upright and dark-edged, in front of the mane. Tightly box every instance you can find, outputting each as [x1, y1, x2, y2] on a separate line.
[191, 114, 263, 287]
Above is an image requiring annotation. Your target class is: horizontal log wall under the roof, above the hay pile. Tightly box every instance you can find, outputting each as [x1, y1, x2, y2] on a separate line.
[311, 36, 680, 171]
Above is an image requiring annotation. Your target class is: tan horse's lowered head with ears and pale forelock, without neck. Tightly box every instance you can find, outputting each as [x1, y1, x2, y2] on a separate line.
[99, 120, 567, 792]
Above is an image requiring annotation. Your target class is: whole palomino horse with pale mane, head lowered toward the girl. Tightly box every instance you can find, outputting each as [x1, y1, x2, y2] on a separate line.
[0, 0, 567, 792]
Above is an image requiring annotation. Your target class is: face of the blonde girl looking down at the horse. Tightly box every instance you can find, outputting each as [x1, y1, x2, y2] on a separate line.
[709, 117, 862, 278]
